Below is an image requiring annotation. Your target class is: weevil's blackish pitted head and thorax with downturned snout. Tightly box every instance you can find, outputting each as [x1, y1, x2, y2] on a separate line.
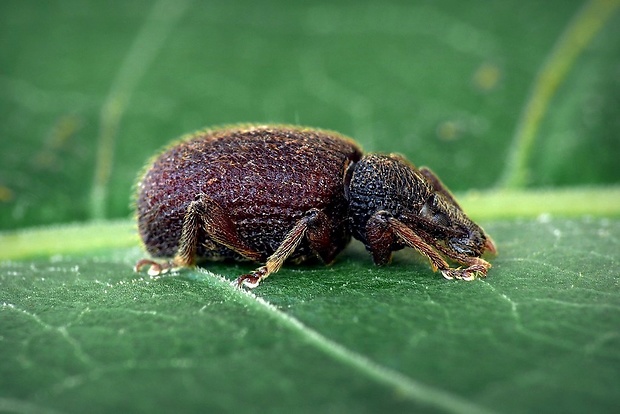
[344, 154, 495, 257]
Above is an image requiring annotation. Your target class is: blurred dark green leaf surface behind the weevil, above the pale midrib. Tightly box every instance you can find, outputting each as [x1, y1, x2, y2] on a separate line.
[0, 0, 620, 229]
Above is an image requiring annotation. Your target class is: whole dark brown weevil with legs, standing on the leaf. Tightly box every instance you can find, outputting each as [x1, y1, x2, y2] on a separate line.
[136, 125, 496, 288]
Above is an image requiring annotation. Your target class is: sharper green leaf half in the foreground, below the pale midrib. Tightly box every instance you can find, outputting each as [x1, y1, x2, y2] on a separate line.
[0, 216, 620, 413]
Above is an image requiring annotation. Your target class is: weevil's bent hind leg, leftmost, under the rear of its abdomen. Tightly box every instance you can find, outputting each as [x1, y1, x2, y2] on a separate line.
[135, 194, 261, 276]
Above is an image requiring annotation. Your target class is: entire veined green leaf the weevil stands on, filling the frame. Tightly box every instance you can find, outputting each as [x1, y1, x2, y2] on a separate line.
[0, 0, 620, 413]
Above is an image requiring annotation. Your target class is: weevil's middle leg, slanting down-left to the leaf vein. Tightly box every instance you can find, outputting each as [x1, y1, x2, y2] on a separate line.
[236, 208, 338, 289]
